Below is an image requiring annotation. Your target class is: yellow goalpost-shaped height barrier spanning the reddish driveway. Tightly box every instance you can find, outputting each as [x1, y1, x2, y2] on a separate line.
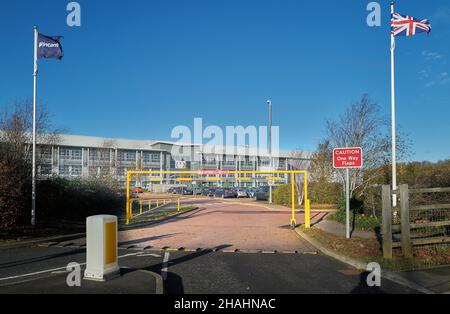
[126, 170, 311, 229]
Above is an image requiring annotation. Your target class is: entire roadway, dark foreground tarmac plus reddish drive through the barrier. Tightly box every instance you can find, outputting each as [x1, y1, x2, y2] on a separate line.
[0, 201, 420, 294]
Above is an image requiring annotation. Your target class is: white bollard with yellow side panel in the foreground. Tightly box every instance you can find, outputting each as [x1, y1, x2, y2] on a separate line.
[84, 215, 120, 281]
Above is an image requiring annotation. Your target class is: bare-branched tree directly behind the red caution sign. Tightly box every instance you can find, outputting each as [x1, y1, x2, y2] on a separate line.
[327, 94, 409, 197]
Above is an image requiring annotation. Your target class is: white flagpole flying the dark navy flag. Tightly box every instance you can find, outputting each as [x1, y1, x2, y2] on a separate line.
[31, 26, 38, 226]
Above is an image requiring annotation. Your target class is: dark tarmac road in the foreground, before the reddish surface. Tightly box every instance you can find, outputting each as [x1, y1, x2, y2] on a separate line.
[0, 247, 415, 294]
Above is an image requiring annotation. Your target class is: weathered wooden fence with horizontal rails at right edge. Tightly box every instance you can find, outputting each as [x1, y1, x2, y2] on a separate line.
[382, 184, 450, 259]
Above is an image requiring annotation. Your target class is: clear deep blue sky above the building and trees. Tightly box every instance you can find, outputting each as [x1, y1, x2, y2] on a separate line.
[0, 0, 450, 161]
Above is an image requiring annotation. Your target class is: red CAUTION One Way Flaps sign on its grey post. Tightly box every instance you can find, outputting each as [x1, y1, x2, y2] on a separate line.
[333, 147, 363, 239]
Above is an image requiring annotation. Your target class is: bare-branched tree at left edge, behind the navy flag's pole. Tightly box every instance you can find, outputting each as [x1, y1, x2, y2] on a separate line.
[0, 101, 59, 228]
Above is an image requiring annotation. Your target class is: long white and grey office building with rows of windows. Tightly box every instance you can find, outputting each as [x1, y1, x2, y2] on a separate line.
[37, 135, 309, 189]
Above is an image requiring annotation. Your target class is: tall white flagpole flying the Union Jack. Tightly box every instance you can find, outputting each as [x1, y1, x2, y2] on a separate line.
[391, 2, 397, 207]
